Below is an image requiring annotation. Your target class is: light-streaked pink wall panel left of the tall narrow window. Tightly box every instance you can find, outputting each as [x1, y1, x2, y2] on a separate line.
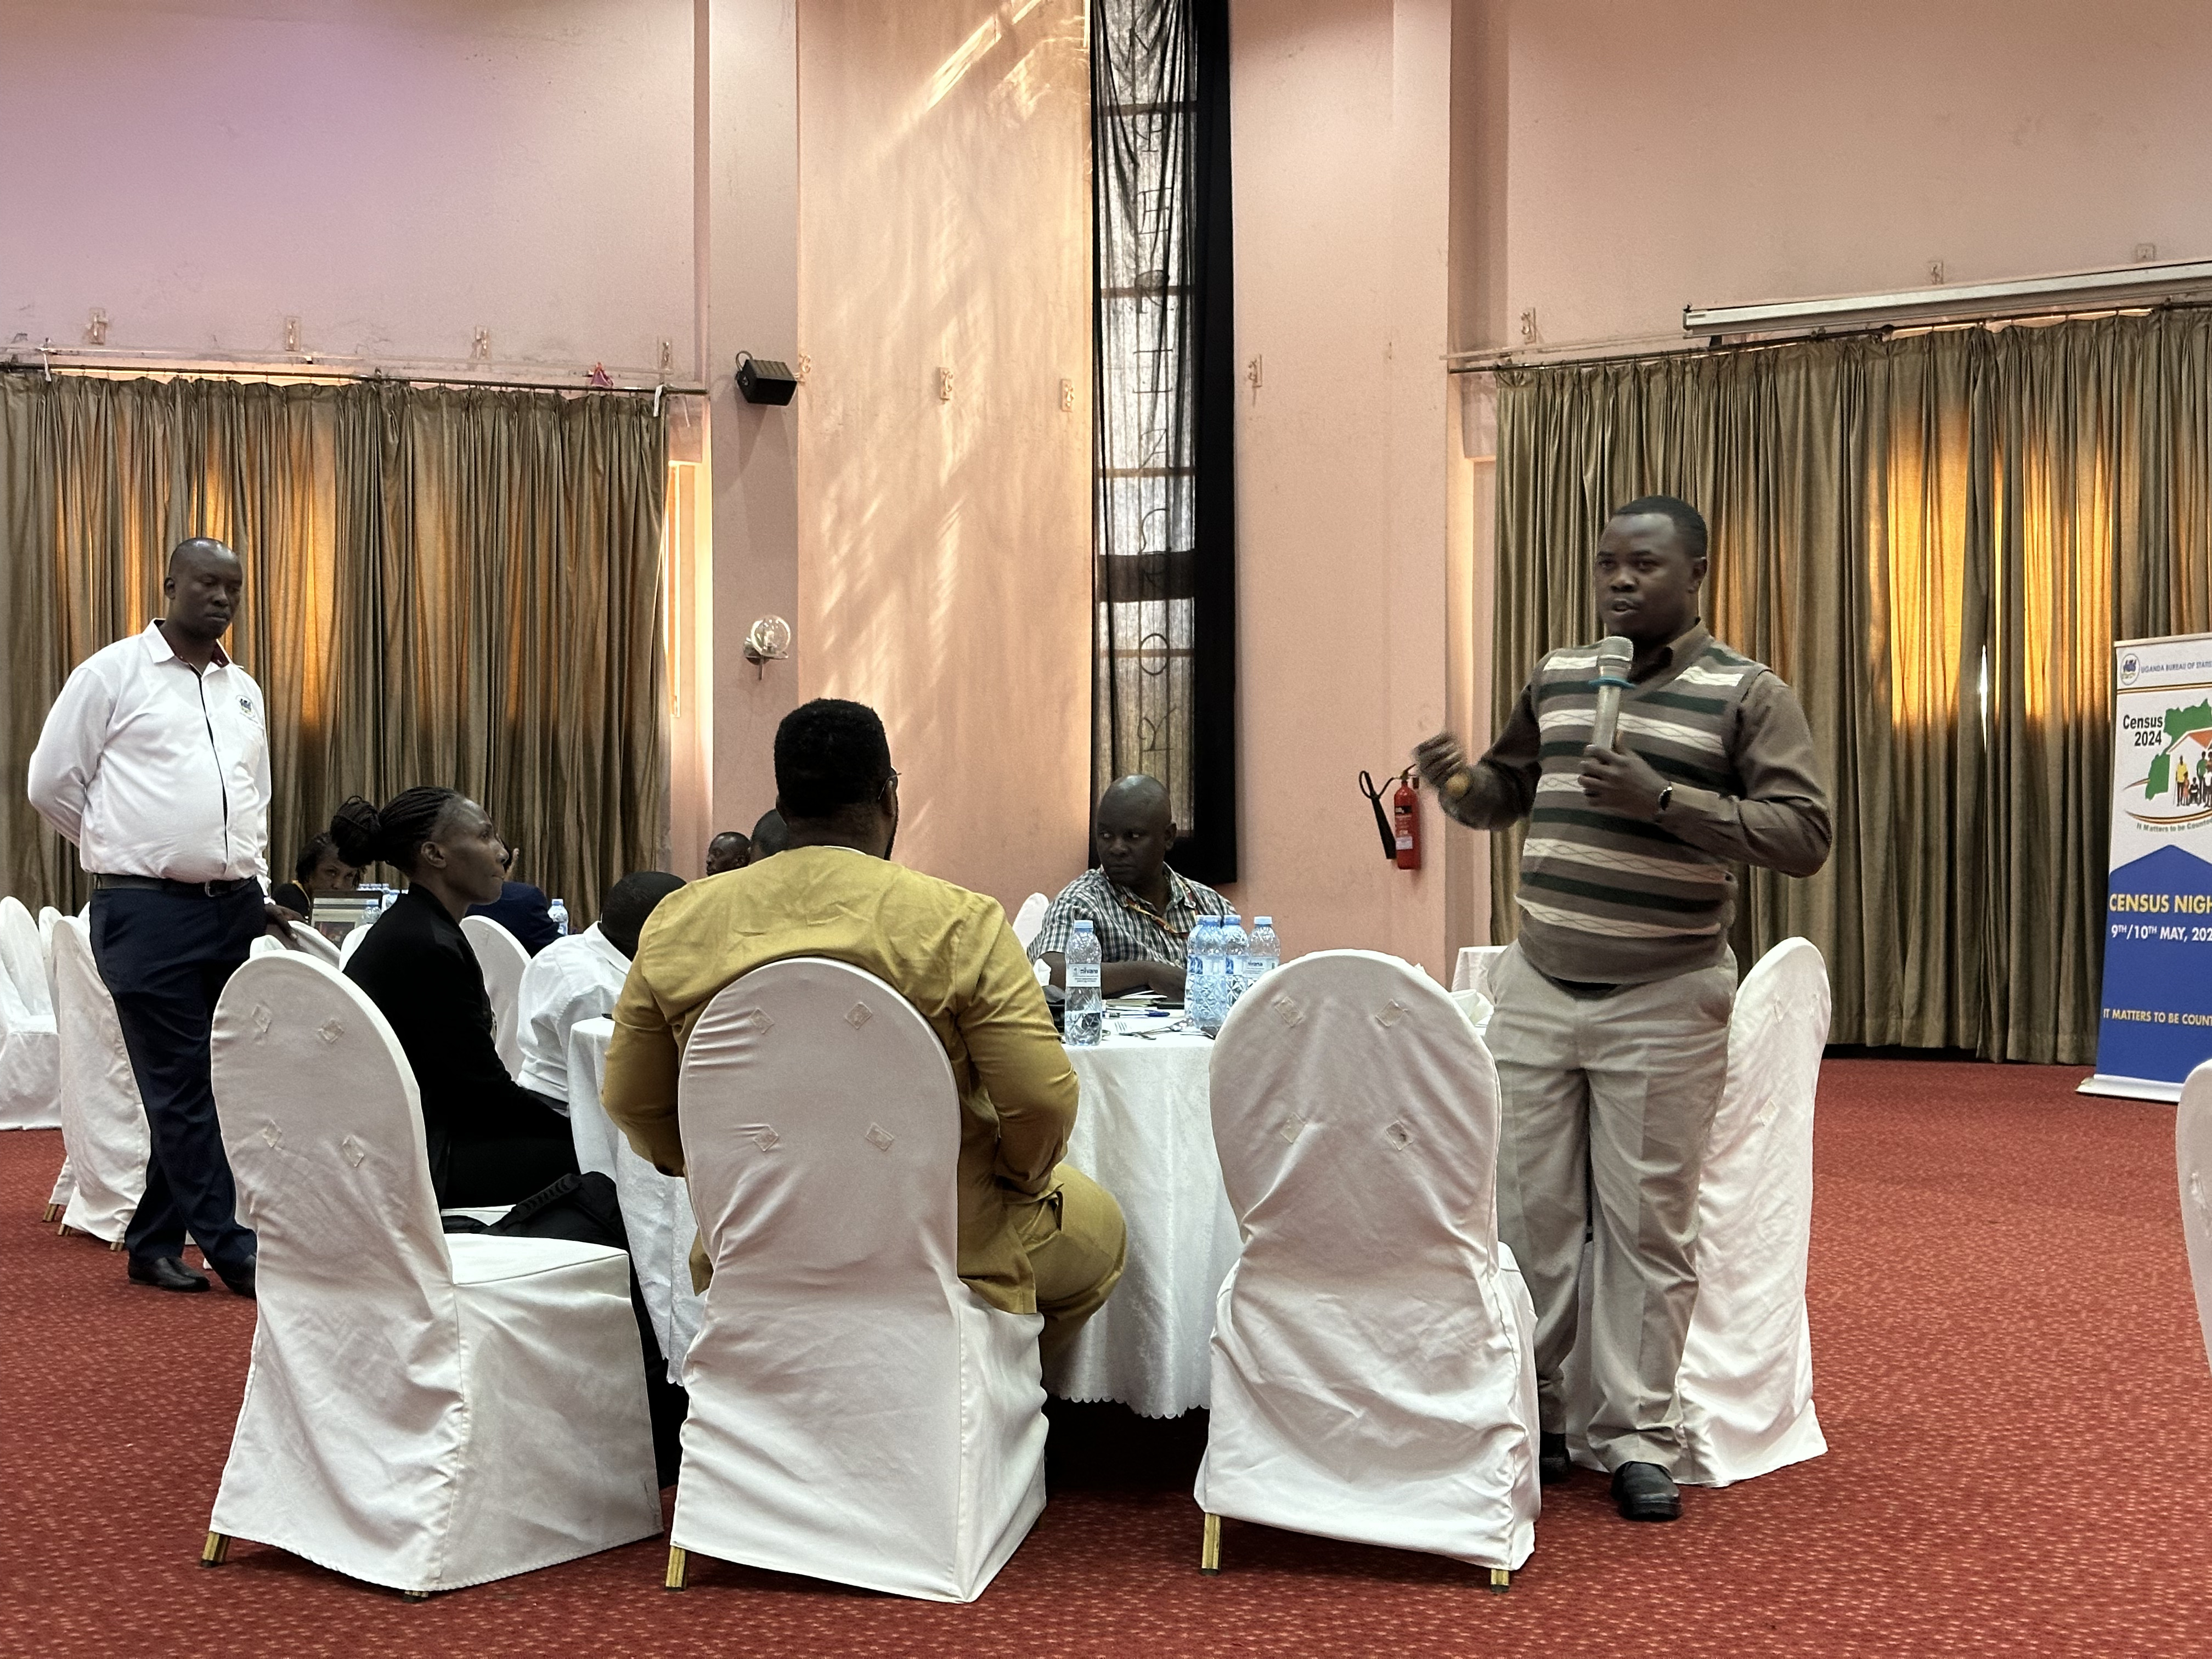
[792, 0, 1091, 911]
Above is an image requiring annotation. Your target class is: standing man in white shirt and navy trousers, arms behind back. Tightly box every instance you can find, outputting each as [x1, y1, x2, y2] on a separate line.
[31, 538, 283, 1296]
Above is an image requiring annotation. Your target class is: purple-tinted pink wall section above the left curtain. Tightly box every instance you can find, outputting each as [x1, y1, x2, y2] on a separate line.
[0, 0, 695, 376]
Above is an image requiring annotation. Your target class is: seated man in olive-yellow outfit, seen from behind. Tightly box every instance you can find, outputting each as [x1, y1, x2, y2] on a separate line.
[604, 699, 1124, 1363]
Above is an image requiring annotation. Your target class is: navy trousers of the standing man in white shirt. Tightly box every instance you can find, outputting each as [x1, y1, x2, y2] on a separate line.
[93, 883, 268, 1274]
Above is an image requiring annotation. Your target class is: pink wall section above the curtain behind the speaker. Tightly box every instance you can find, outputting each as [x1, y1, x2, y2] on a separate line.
[1453, 0, 2212, 345]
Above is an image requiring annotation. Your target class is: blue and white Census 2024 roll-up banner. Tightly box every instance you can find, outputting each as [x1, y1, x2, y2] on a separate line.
[2081, 633, 2212, 1099]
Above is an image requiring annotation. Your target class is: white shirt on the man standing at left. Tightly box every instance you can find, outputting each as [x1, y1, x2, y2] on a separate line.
[31, 624, 270, 885]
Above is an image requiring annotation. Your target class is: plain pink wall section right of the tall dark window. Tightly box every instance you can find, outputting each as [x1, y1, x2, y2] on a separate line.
[1230, 0, 1464, 975]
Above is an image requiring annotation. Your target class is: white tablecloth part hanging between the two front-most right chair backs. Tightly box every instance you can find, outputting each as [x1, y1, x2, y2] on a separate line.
[1046, 1033, 1237, 1418]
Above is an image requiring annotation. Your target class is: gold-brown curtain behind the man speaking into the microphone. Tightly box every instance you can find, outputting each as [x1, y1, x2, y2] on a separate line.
[1491, 309, 2212, 1064]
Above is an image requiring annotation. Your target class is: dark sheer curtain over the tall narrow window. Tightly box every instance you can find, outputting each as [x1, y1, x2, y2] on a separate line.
[1091, 0, 1237, 883]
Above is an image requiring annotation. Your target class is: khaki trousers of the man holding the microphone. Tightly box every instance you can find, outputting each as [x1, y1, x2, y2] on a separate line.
[1489, 945, 1736, 1473]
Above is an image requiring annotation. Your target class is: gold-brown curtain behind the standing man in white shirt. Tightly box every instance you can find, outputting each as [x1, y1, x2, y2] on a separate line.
[0, 376, 666, 924]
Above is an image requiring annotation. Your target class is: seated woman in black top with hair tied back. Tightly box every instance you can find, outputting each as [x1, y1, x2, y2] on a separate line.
[330, 789, 575, 1210]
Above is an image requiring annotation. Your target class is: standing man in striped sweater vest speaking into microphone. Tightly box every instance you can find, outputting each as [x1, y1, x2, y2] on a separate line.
[1413, 495, 1829, 1520]
